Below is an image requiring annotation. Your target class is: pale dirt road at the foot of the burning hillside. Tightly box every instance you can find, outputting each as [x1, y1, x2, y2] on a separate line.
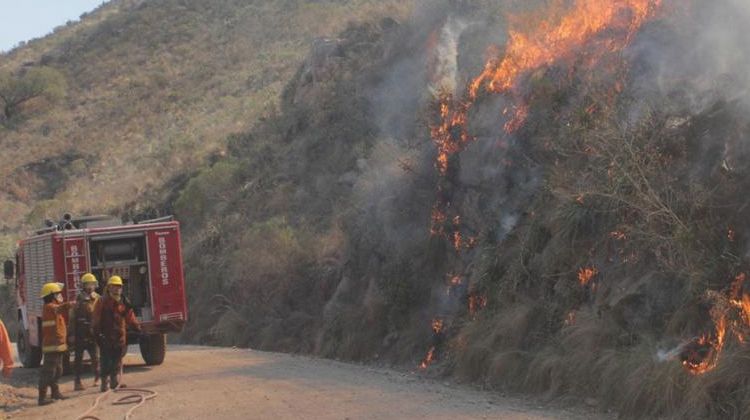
[0, 346, 604, 420]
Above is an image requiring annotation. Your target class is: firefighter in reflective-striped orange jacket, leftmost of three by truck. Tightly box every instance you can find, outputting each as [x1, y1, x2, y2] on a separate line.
[39, 283, 73, 405]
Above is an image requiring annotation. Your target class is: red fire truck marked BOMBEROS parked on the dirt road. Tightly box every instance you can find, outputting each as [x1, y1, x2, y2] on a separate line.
[4, 213, 187, 367]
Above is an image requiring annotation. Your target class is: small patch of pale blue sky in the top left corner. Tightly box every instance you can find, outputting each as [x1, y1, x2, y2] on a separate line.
[0, 0, 105, 52]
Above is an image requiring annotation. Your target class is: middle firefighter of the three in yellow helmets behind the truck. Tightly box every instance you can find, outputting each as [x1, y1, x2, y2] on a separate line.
[72, 273, 100, 391]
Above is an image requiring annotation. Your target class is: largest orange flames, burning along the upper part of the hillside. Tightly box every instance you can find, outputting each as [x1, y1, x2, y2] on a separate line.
[431, 0, 663, 238]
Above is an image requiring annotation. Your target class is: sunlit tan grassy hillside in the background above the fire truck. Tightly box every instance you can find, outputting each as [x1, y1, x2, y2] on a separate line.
[0, 0, 409, 254]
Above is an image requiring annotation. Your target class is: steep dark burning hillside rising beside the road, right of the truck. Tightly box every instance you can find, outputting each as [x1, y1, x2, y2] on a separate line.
[173, 0, 750, 419]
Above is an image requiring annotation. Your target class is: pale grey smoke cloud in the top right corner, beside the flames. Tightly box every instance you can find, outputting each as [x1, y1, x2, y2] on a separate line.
[630, 0, 750, 115]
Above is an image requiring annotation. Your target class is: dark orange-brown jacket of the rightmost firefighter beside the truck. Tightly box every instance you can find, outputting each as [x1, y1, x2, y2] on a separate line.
[92, 294, 141, 351]
